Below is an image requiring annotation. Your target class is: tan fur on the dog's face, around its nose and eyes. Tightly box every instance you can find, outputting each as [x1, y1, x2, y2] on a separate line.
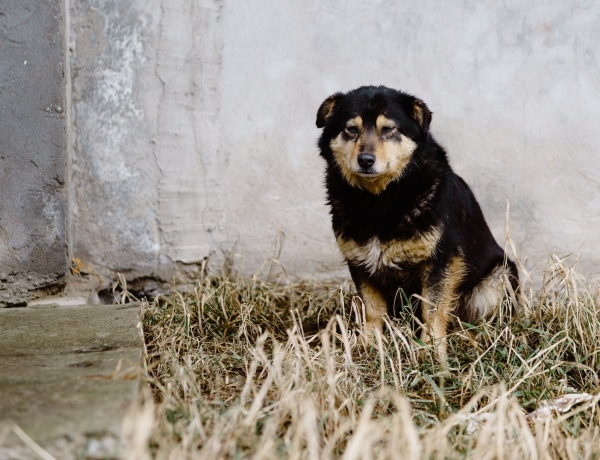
[329, 115, 417, 195]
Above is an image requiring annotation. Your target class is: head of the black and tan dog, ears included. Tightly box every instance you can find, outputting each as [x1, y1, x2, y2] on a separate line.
[317, 86, 431, 194]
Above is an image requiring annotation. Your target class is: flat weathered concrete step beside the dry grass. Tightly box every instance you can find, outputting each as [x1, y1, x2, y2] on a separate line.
[0, 304, 142, 460]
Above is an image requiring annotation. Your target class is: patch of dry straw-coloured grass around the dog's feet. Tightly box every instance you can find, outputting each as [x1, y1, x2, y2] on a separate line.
[130, 259, 600, 460]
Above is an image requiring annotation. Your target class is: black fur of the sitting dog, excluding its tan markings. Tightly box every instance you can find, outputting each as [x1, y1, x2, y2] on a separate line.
[317, 86, 518, 338]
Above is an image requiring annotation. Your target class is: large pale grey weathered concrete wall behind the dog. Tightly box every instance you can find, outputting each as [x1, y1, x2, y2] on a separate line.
[45, 0, 600, 294]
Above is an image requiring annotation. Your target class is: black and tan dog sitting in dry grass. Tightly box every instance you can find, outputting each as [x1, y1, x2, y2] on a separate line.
[317, 86, 518, 360]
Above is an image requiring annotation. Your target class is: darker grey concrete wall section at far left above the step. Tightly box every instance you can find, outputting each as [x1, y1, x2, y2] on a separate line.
[0, 0, 67, 307]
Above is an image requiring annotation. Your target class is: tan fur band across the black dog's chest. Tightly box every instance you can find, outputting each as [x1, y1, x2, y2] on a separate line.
[337, 228, 441, 276]
